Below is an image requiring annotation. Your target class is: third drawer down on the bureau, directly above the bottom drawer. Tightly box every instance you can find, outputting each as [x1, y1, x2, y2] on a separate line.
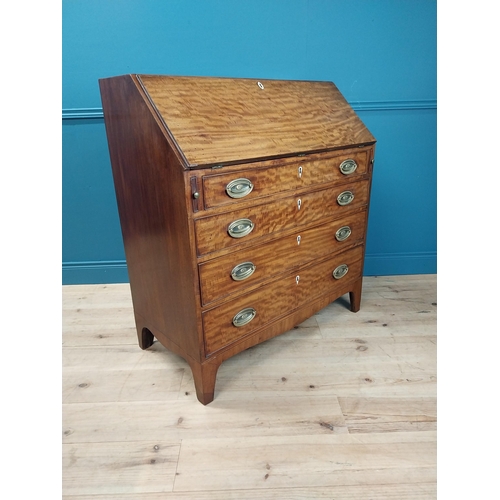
[199, 211, 367, 305]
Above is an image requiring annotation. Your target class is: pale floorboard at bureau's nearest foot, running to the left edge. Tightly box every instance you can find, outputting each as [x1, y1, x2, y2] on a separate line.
[63, 396, 347, 444]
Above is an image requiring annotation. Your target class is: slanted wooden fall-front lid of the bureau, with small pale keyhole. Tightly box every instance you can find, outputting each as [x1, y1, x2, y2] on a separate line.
[138, 75, 375, 167]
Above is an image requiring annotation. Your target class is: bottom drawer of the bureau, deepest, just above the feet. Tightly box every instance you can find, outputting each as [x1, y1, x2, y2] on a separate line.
[202, 245, 363, 356]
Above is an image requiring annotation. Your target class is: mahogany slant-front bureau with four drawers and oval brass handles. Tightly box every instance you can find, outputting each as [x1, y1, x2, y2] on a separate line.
[99, 75, 375, 404]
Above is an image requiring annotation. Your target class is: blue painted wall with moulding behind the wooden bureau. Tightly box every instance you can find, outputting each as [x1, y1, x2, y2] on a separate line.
[62, 0, 437, 284]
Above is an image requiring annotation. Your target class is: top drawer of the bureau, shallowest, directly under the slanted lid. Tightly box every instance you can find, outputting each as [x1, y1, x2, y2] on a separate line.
[203, 151, 368, 208]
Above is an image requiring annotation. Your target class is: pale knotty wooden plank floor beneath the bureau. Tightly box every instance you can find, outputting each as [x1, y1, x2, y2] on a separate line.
[62, 275, 436, 500]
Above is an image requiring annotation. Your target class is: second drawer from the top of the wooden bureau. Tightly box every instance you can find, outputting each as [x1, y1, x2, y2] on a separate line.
[195, 180, 369, 255]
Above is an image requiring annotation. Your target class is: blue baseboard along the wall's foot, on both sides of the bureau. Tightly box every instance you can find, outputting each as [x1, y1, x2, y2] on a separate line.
[62, 252, 437, 285]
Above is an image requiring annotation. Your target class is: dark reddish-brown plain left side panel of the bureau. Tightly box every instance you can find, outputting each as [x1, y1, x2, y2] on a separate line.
[99, 76, 200, 360]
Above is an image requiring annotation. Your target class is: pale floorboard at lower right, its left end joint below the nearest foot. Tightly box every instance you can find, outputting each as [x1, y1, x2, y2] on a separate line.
[175, 431, 436, 491]
